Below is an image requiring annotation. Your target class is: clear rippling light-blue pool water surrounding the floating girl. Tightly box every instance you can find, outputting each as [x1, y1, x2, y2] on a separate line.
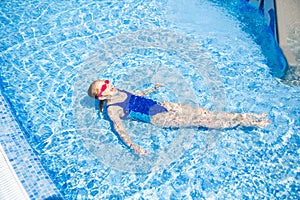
[0, 0, 300, 199]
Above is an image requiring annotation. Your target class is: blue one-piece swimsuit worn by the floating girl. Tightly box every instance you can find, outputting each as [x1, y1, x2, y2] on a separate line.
[107, 90, 168, 122]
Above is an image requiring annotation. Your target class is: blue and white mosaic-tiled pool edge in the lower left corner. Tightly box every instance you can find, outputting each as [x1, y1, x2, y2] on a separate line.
[0, 89, 63, 199]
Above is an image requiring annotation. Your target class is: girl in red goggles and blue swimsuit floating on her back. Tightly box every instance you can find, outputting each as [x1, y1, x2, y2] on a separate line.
[88, 80, 270, 155]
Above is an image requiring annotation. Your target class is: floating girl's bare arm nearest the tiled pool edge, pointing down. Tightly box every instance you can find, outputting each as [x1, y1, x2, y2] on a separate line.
[108, 106, 147, 155]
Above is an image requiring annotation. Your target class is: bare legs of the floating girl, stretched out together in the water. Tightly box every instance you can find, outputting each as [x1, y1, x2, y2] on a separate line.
[151, 102, 270, 129]
